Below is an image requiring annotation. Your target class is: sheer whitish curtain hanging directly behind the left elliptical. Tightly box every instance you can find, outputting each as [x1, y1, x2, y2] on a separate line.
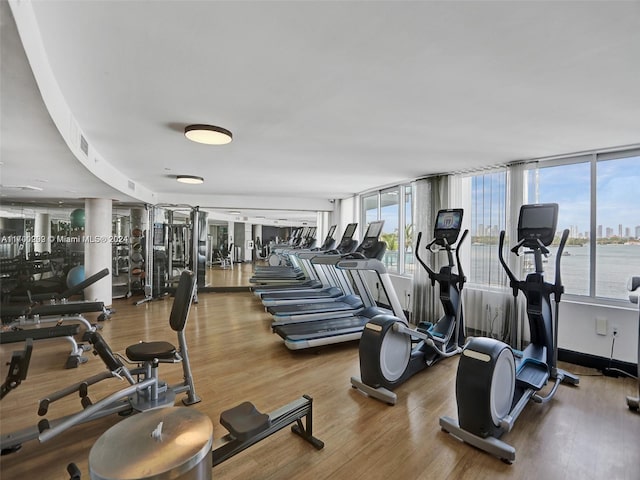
[411, 175, 450, 324]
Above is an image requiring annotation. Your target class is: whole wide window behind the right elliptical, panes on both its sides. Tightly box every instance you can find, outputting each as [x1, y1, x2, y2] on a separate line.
[468, 146, 640, 300]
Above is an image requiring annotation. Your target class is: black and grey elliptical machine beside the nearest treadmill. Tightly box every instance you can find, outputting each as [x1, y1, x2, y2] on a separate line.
[351, 209, 469, 405]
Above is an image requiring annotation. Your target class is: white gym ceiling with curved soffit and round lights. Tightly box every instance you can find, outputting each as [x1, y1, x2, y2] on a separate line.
[0, 0, 640, 220]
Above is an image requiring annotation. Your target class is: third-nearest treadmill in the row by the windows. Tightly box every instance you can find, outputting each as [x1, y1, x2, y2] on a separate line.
[253, 223, 358, 298]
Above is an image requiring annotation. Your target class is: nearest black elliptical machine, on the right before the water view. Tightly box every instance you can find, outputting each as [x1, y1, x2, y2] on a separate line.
[440, 203, 579, 464]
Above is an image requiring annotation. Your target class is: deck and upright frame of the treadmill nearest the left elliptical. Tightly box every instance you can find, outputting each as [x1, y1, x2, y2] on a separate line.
[272, 244, 406, 350]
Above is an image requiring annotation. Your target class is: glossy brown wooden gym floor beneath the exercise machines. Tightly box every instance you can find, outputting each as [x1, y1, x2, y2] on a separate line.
[0, 264, 640, 480]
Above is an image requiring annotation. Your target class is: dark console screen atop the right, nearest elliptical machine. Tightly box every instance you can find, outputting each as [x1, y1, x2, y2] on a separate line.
[518, 203, 558, 247]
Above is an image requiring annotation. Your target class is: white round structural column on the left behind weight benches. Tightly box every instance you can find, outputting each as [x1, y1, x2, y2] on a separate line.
[84, 198, 113, 306]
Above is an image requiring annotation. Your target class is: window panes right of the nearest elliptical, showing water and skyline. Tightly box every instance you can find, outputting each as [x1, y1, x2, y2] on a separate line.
[525, 150, 640, 300]
